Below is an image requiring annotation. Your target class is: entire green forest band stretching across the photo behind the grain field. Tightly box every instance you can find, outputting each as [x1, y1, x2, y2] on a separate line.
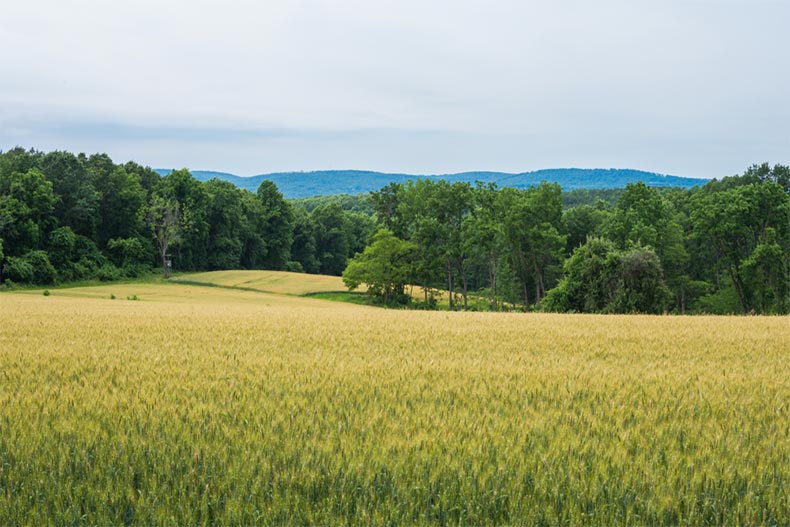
[0, 148, 790, 313]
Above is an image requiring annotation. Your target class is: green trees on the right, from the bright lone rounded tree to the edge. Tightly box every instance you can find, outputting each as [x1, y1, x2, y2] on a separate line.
[343, 164, 790, 313]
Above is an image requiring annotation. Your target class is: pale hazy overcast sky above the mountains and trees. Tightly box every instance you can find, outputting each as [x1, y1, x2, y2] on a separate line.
[0, 0, 790, 177]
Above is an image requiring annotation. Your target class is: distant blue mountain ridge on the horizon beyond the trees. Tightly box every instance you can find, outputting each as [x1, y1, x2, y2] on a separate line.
[156, 168, 708, 199]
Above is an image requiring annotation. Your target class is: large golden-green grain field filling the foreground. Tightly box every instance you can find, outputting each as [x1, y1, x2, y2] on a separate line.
[0, 284, 790, 525]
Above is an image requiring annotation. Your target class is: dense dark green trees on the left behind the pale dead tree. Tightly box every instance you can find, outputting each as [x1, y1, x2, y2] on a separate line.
[0, 148, 375, 287]
